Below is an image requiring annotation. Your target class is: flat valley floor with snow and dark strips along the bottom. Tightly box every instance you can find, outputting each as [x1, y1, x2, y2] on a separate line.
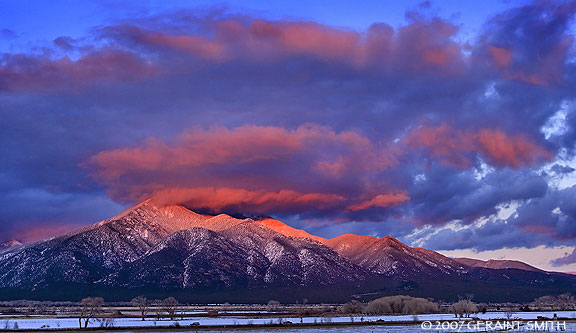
[0, 311, 576, 333]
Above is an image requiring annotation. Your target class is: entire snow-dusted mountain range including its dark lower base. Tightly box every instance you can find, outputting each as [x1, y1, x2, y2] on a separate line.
[0, 200, 576, 302]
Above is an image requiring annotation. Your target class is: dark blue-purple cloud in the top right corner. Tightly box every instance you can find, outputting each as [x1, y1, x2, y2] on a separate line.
[476, 1, 576, 85]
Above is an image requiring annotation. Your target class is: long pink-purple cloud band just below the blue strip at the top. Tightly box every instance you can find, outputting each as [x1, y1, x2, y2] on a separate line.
[100, 17, 465, 75]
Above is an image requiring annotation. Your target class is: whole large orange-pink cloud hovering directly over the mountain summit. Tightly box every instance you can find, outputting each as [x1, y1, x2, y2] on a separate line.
[87, 124, 409, 215]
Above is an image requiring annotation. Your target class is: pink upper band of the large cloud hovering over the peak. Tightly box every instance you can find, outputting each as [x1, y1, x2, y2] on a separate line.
[91, 124, 397, 180]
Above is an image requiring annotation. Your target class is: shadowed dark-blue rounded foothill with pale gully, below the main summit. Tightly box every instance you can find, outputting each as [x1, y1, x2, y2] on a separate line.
[120, 228, 269, 289]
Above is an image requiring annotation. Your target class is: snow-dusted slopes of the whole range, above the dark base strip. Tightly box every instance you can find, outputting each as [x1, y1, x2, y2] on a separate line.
[0, 200, 571, 296]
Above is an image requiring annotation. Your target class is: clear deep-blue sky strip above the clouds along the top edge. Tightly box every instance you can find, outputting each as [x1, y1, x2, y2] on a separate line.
[0, 0, 521, 50]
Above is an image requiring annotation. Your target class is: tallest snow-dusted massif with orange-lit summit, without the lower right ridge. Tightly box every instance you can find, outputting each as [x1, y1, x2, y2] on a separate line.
[0, 201, 365, 289]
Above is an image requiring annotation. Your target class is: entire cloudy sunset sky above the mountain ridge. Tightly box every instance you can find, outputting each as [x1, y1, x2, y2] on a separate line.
[0, 0, 576, 271]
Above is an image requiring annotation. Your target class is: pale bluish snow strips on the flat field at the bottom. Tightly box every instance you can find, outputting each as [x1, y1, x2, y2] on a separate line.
[0, 311, 576, 332]
